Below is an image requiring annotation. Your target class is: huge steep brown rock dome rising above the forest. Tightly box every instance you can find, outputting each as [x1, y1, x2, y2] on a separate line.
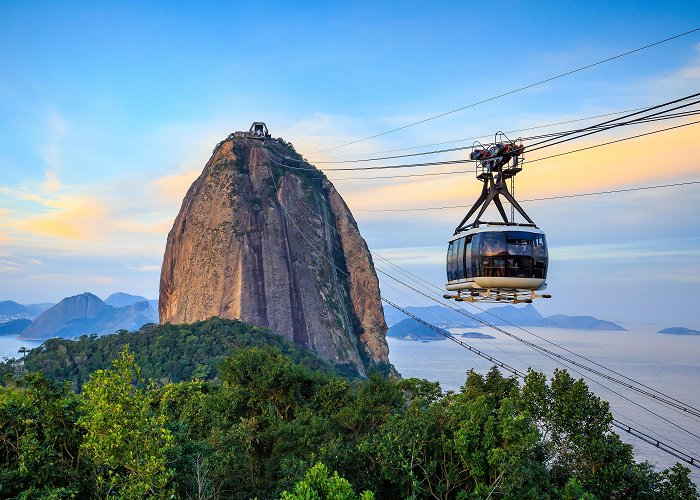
[159, 137, 390, 374]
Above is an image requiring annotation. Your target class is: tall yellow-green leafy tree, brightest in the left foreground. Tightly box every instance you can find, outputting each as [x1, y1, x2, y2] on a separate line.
[78, 348, 172, 498]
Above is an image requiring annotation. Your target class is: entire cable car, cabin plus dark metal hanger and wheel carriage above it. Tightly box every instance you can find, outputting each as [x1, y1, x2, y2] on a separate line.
[445, 133, 550, 304]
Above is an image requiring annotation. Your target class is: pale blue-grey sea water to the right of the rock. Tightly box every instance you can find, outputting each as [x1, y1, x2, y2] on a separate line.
[388, 325, 700, 485]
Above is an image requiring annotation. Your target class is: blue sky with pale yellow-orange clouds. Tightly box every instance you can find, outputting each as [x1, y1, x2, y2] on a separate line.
[0, 1, 700, 328]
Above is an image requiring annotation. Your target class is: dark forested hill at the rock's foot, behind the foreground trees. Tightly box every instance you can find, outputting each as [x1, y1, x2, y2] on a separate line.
[0, 316, 350, 389]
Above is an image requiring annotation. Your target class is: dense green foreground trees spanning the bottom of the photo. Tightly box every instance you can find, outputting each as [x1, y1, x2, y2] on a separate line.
[0, 320, 697, 499]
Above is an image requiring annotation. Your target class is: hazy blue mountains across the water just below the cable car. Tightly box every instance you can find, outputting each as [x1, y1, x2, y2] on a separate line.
[384, 304, 625, 331]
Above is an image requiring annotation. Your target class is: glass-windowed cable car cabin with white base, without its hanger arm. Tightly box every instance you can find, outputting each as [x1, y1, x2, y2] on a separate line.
[446, 224, 548, 303]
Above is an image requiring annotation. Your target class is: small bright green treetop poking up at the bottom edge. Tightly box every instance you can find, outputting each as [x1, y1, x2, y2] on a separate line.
[282, 462, 374, 500]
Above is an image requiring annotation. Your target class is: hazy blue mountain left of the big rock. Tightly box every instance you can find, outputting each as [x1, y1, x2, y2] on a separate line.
[21, 292, 158, 339]
